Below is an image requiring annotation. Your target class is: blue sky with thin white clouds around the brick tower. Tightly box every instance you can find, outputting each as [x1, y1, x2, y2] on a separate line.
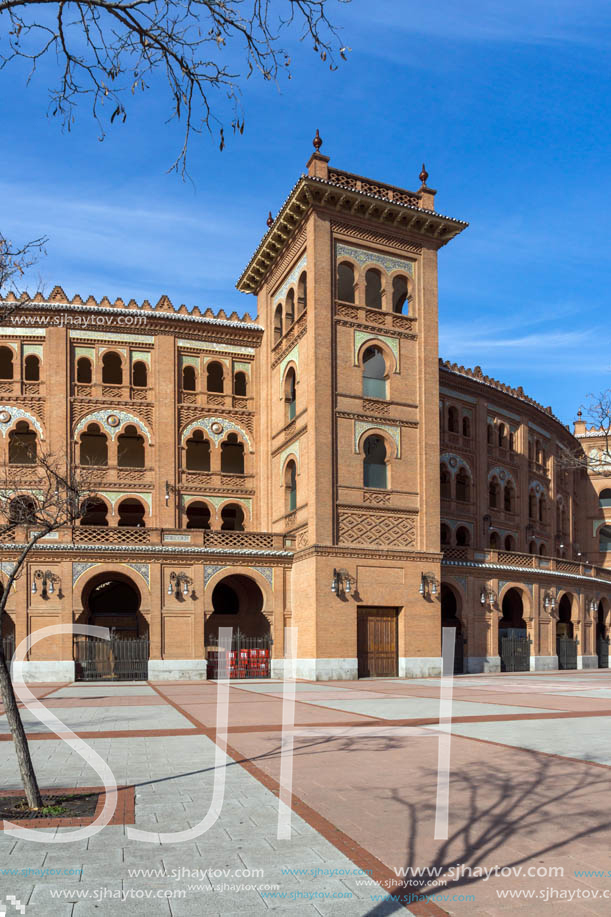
[0, 0, 611, 422]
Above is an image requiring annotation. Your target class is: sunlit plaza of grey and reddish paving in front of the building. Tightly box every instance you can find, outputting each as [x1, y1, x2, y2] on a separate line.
[0, 671, 611, 917]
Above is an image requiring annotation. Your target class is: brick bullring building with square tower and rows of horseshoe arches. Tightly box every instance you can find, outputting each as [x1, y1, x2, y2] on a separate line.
[0, 149, 611, 681]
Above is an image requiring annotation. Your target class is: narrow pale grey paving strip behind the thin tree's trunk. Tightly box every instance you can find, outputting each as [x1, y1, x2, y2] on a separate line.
[0, 703, 195, 735]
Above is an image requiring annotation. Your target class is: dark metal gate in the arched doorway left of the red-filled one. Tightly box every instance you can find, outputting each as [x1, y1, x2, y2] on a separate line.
[74, 636, 149, 681]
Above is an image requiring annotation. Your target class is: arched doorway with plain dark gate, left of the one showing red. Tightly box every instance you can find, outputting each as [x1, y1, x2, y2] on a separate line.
[74, 572, 149, 681]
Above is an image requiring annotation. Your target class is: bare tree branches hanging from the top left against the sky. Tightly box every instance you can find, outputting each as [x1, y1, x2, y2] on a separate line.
[0, 0, 350, 175]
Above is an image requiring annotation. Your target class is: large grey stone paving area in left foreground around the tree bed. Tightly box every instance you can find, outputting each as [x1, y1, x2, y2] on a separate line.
[0, 736, 396, 917]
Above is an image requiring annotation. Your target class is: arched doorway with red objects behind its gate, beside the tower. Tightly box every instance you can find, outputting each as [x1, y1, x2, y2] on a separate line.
[204, 573, 272, 678]
